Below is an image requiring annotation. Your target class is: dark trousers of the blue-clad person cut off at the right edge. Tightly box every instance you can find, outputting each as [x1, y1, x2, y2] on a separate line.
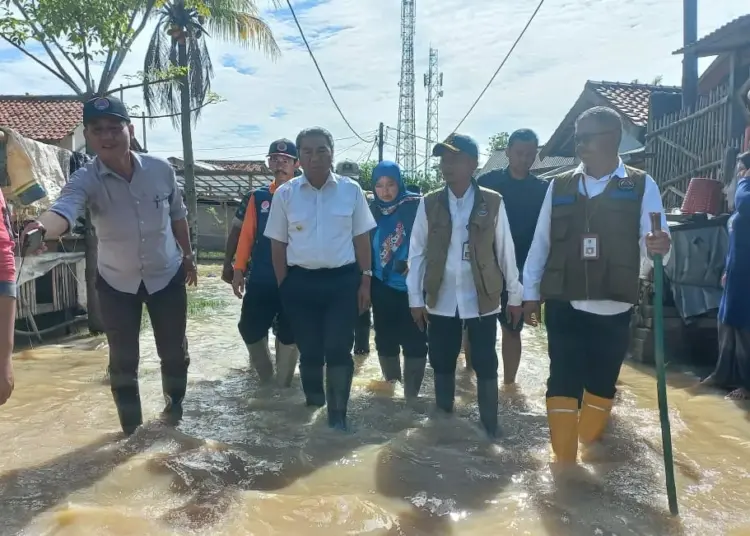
[713, 322, 750, 390]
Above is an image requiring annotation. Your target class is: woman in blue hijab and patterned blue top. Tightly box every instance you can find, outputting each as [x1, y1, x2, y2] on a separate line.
[370, 161, 427, 399]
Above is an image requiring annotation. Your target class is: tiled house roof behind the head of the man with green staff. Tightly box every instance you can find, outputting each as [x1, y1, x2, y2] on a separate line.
[539, 80, 682, 160]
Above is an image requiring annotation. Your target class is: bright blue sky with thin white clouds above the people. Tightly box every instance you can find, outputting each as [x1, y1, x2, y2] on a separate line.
[0, 0, 747, 168]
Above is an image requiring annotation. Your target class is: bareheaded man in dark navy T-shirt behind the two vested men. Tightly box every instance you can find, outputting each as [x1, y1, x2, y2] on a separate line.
[477, 128, 549, 385]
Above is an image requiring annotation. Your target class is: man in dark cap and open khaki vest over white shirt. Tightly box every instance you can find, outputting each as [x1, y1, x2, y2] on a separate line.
[406, 134, 523, 437]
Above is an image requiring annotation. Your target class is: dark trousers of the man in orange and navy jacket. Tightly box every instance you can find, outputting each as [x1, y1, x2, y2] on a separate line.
[237, 281, 294, 345]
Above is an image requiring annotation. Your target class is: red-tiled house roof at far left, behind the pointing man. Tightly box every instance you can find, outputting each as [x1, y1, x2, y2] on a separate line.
[0, 95, 83, 141]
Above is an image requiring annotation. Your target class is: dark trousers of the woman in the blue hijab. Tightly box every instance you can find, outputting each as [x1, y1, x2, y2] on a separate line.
[370, 277, 427, 358]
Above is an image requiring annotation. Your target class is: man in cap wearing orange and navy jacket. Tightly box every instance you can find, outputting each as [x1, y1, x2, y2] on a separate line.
[232, 139, 299, 387]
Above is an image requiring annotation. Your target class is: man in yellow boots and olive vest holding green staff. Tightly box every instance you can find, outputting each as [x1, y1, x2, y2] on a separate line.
[523, 107, 671, 463]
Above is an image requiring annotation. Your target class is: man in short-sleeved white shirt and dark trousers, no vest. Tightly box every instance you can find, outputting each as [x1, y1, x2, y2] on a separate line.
[264, 128, 375, 430]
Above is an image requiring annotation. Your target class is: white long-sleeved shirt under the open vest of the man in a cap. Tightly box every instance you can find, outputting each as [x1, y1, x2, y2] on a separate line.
[406, 187, 523, 319]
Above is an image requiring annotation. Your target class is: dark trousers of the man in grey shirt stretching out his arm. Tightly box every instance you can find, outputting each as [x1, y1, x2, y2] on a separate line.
[96, 267, 190, 418]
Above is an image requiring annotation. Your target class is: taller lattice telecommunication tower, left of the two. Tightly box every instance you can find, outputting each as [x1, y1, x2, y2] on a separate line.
[396, 0, 417, 175]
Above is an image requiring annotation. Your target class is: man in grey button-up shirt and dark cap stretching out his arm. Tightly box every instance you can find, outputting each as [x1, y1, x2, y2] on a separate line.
[24, 97, 197, 434]
